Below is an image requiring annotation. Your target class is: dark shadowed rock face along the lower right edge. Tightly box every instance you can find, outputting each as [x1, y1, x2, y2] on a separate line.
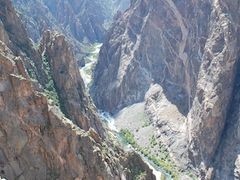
[214, 64, 240, 180]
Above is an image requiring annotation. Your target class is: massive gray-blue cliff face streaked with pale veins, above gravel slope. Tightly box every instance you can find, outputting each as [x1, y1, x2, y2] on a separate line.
[91, 0, 211, 114]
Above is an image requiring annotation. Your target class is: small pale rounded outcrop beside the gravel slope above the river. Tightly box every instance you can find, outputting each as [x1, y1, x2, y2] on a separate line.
[145, 84, 189, 169]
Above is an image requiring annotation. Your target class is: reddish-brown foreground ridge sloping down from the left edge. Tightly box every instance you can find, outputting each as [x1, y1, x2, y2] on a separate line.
[0, 41, 155, 180]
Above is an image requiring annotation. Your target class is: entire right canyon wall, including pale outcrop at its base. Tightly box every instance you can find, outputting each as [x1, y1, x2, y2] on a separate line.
[91, 0, 240, 179]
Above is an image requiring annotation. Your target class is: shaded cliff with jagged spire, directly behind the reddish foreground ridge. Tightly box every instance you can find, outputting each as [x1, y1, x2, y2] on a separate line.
[0, 1, 103, 135]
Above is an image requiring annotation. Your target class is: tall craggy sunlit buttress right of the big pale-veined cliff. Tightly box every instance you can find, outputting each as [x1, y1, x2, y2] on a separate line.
[188, 0, 240, 170]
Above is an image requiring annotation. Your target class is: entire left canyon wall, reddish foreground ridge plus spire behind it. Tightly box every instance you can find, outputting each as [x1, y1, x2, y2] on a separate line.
[0, 0, 155, 180]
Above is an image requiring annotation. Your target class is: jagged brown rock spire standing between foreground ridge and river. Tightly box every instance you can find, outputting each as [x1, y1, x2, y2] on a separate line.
[39, 31, 103, 135]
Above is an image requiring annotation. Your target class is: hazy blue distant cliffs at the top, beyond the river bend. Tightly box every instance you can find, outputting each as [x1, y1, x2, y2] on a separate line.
[13, 0, 129, 43]
